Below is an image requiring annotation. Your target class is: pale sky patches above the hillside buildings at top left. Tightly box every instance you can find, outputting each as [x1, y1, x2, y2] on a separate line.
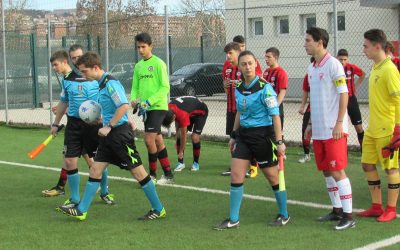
[25, 0, 178, 10]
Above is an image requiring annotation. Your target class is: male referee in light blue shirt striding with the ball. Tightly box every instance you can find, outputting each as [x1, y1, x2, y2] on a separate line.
[60, 52, 166, 220]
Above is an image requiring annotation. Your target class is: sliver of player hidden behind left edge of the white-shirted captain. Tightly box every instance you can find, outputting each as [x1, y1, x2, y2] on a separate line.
[298, 57, 315, 163]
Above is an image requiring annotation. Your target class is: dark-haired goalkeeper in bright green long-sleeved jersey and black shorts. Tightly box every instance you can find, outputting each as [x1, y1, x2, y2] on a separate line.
[130, 33, 174, 184]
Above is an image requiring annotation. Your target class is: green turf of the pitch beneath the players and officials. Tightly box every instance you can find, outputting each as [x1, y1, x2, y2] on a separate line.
[0, 126, 400, 249]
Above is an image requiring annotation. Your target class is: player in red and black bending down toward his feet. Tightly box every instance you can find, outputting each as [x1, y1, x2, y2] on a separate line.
[162, 96, 208, 172]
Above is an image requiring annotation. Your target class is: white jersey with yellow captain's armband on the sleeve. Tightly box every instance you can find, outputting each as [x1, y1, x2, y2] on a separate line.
[307, 53, 349, 140]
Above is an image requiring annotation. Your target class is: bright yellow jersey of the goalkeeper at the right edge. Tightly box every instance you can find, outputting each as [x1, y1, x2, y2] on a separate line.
[365, 57, 400, 138]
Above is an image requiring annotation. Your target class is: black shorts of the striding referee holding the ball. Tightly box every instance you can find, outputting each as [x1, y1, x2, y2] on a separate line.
[94, 123, 142, 170]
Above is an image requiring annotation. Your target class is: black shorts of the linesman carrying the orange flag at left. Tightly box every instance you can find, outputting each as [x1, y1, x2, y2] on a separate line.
[63, 116, 101, 158]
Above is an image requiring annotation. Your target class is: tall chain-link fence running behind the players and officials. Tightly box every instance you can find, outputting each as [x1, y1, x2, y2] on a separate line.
[0, 0, 400, 145]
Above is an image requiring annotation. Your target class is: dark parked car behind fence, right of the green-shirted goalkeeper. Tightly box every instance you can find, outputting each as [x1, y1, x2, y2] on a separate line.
[169, 63, 224, 96]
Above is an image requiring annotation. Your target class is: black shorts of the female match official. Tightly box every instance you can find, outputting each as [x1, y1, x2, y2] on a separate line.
[232, 126, 278, 168]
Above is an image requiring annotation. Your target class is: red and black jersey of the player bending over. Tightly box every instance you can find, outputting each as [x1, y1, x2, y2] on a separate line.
[168, 96, 208, 128]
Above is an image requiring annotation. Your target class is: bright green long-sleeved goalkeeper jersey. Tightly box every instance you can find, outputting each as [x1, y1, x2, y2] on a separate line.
[131, 55, 170, 110]
